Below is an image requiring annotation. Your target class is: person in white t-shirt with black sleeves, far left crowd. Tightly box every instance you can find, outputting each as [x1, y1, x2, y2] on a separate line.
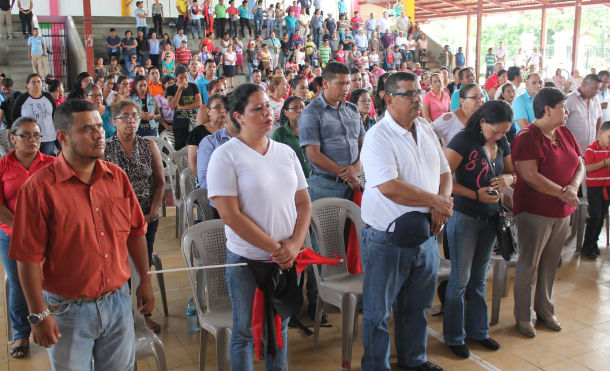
[11, 73, 55, 156]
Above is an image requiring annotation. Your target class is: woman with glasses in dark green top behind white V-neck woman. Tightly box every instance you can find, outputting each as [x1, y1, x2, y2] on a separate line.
[271, 96, 311, 178]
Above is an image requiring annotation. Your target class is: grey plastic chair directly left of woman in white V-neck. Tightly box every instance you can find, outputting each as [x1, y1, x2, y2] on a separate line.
[182, 219, 233, 370]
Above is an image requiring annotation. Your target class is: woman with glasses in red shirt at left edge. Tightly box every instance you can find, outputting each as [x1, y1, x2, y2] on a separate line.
[0, 116, 55, 358]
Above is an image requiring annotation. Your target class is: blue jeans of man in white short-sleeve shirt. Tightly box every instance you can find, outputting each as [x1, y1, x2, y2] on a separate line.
[361, 227, 440, 371]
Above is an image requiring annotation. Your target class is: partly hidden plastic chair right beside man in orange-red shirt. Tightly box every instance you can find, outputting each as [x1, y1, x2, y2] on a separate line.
[129, 258, 167, 371]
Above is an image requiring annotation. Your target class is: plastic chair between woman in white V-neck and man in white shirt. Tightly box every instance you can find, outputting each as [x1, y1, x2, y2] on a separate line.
[311, 198, 364, 369]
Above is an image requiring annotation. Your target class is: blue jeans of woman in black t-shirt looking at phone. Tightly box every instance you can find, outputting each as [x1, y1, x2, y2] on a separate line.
[443, 210, 496, 345]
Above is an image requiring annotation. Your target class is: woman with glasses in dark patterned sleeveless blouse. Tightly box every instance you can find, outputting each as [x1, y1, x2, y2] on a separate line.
[104, 99, 165, 333]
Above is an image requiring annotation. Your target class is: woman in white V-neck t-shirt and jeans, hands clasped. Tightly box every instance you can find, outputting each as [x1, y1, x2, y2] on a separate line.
[207, 84, 311, 370]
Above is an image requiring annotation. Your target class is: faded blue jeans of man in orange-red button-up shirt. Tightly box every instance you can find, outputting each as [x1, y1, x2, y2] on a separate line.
[42, 282, 136, 370]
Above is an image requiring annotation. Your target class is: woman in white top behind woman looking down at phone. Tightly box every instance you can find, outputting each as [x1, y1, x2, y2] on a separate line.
[432, 84, 485, 148]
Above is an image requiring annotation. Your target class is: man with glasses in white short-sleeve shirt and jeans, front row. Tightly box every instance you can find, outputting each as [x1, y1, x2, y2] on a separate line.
[361, 72, 453, 371]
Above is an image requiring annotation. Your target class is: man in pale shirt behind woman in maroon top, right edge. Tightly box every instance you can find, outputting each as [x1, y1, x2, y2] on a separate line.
[566, 74, 602, 153]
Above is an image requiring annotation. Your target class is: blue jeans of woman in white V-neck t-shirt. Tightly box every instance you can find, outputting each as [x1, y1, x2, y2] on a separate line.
[225, 250, 290, 371]
